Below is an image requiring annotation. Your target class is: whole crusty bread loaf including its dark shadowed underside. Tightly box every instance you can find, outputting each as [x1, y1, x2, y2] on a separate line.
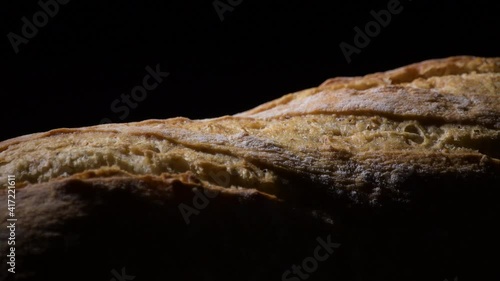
[0, 57, 500, 281]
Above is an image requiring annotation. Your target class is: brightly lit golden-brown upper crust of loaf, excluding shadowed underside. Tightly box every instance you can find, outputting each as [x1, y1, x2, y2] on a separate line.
[0, 57, 500, 201]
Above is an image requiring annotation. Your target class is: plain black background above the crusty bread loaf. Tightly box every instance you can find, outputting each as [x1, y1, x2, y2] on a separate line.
[0, 0, 500, 140]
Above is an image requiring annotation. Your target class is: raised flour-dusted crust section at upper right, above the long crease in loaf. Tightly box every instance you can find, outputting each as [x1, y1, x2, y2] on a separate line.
[237, 57, 500, 129]
